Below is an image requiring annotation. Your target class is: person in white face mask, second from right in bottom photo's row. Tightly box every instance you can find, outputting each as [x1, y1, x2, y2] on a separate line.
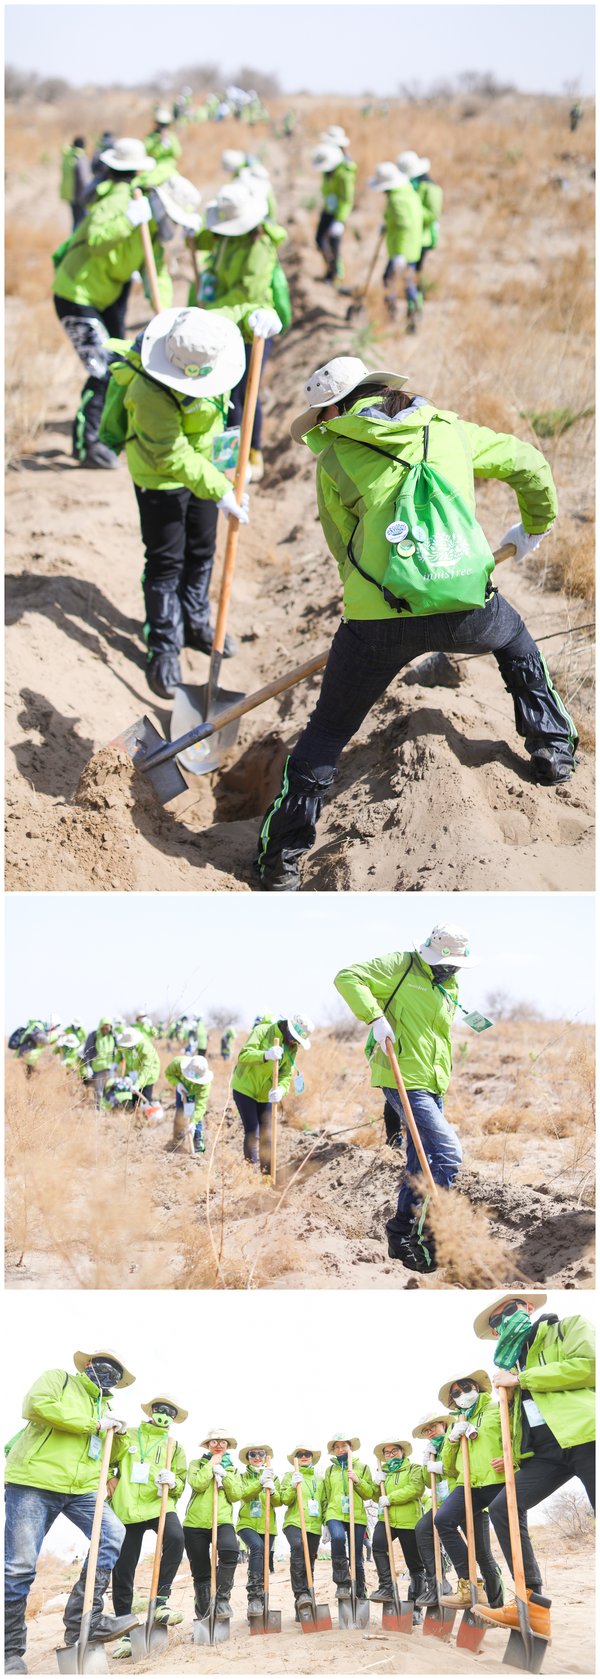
[435, 1370, 510, 1608]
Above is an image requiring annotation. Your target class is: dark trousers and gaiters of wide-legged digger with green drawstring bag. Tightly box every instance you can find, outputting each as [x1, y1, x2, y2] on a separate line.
[259, 591, 576, 878]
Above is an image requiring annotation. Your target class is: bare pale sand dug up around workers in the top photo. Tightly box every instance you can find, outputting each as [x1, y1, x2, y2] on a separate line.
[7, 99, 593, 892]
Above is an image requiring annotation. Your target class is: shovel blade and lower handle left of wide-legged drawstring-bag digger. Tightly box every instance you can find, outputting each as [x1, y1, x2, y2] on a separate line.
[109, 651, 329, 804]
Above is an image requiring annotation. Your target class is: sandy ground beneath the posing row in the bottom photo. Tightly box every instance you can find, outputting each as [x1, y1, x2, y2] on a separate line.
[23, 1528, 595, 1674]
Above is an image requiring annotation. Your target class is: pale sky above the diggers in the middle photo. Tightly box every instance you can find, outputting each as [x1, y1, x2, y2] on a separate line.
[5, 892, 595, 1034]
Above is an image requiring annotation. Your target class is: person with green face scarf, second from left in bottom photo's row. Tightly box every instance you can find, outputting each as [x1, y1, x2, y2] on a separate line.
[108, 1390, 188, 1661]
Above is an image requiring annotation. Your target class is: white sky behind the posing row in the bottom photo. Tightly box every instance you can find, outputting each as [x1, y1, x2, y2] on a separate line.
[2, 1289, 595, 1555]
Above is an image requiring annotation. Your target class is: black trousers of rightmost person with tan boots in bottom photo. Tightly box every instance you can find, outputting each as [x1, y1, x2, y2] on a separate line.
[487, 1425, 595, 1592]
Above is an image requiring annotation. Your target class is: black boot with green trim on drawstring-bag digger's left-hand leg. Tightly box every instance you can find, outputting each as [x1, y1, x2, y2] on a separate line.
[257, 754, 333, 892]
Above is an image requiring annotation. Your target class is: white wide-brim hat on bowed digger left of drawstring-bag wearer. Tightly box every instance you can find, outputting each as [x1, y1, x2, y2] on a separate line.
[141, 309, 245, 398]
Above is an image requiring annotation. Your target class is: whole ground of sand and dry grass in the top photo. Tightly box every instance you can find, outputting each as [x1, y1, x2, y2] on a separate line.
[7, 94, 593, 892]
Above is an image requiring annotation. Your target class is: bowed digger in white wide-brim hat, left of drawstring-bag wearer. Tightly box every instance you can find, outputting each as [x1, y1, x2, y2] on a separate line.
[103, 307, 279, 700]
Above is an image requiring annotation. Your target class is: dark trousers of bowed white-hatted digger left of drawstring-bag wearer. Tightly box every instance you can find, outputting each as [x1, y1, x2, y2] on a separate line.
[134, 484, 218, 653]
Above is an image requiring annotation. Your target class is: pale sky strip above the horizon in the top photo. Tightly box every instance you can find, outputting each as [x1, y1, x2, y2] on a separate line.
[5, 0, 595, 96]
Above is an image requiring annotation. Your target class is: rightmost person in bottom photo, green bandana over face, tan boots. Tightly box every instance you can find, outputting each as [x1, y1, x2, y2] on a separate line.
[474, 1289, 595, 1637]
